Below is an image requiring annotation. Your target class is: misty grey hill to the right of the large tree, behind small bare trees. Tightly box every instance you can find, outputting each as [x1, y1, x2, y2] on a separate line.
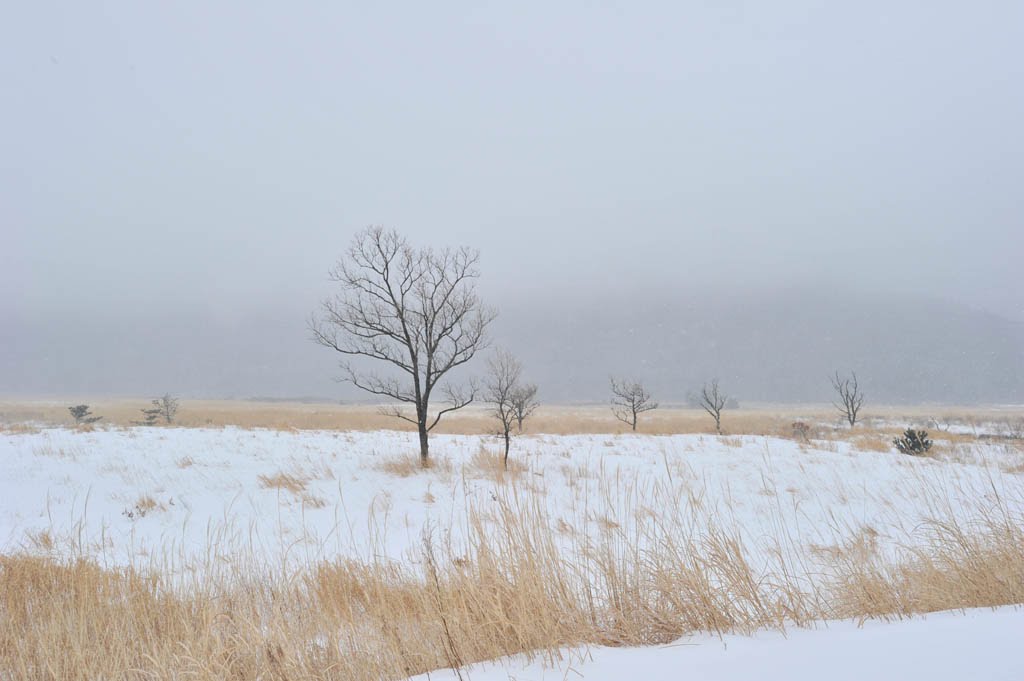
[491, 291, 1024, 402]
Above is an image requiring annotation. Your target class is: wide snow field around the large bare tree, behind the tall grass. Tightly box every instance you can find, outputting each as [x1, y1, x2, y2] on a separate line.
[0, 428, 1024, 562]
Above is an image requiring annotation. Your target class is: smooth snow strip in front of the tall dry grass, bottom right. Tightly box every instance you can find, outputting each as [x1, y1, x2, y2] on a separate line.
[415, 607, 1024, 681]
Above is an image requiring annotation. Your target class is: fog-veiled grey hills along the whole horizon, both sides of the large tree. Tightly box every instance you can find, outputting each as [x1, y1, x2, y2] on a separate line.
[0, 290, 1024, 403]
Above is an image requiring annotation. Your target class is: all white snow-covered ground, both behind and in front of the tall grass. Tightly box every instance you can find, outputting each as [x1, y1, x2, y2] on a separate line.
[0, 428, 1024, 681]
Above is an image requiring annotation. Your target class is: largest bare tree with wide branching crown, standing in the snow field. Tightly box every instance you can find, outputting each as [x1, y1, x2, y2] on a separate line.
[309, 227, 496, 465]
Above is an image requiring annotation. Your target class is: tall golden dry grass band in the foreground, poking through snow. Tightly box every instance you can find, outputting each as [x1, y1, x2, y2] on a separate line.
[0, 473, 1024, 681]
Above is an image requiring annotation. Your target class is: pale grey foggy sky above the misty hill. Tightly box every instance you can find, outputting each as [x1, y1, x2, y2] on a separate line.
[0, 1, 1024, 394]
